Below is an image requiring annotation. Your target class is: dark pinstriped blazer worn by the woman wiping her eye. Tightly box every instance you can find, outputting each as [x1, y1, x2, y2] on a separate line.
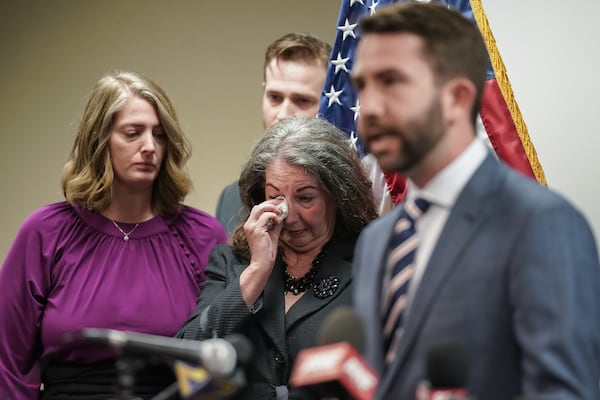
[177, 239, 355, 400]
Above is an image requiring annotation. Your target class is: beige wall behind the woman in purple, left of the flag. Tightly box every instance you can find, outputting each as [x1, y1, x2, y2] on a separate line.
[0, 0, 339, 261]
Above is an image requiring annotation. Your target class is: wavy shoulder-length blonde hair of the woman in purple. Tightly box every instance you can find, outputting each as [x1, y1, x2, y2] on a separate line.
[61, 71, 192, 214]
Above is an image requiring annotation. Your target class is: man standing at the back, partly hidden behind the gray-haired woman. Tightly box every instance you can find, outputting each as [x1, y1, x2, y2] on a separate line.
[215, 33, 331, 235]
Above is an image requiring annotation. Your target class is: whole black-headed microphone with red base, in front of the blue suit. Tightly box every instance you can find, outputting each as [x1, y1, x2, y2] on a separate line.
[416, 341, 469, 400]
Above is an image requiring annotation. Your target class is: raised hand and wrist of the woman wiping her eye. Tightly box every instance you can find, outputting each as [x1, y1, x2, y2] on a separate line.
[240, 196, 285, 306]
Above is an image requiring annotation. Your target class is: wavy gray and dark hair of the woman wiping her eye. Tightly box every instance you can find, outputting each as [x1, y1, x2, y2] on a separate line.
[232, 116, 377, 255]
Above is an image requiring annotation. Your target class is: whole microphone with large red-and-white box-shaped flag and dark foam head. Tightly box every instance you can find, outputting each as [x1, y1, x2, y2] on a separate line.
[290, 307, 379, 400]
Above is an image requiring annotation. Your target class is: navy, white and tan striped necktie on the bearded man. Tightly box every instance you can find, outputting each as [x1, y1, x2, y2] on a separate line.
[383, 199, 430, 363]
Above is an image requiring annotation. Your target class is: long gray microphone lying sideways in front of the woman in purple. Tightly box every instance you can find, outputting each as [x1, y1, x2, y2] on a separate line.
[79, 328, 252, 378]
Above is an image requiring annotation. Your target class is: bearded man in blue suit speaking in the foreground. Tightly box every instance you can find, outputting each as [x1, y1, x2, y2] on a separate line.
[352, 2, 600, 400]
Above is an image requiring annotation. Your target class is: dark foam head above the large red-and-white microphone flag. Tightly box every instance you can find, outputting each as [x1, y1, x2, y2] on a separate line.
[317, 306, 365, 353]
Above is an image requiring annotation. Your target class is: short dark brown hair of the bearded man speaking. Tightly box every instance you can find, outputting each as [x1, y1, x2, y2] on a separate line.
[359, 2, 489, 124]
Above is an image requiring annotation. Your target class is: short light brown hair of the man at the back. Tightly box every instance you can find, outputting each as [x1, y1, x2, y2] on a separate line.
[263, 32, 331, 78]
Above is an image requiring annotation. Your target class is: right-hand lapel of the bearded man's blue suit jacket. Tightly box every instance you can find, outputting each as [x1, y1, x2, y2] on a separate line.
[381, 155, 499, 393]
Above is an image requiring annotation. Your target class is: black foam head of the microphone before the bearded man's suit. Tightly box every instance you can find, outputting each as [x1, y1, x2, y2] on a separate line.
[426, 340, 469, 388]
